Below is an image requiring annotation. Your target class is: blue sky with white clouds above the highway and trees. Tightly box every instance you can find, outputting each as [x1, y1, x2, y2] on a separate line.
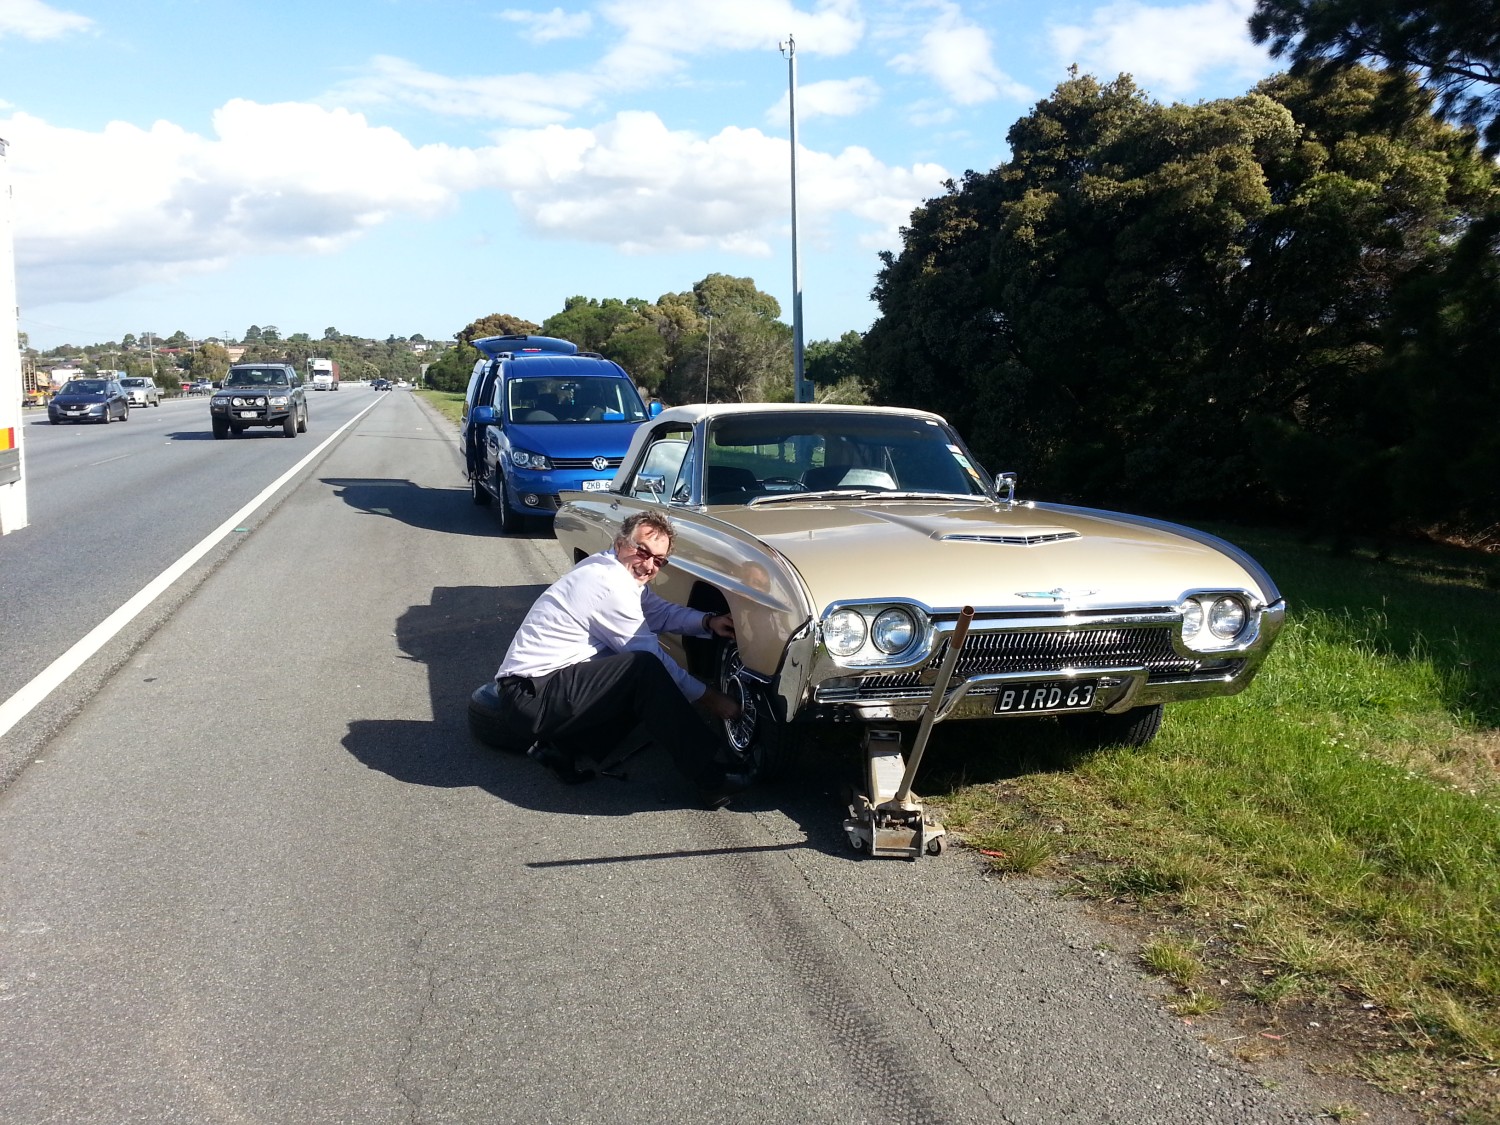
[0, 0, 1281, 350]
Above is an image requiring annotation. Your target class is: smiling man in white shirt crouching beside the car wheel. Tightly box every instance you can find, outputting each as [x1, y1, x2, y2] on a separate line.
[495, 512, 744, 809]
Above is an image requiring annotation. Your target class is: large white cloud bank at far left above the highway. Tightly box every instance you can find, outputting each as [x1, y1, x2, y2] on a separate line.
[0, 101, 480, 305]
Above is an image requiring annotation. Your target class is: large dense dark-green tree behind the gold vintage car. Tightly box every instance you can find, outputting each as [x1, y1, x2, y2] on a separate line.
[866, 68, 1496, 534]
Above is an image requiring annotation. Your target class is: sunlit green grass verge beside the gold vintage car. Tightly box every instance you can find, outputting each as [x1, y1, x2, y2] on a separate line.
[927, 531, 1500, 1121]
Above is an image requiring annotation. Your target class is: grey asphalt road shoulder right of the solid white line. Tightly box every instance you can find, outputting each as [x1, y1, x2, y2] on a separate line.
[0, 392, 1374, 1125]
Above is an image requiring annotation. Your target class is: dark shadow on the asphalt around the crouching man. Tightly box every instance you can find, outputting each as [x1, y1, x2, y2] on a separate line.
[342, 585, 849, 855]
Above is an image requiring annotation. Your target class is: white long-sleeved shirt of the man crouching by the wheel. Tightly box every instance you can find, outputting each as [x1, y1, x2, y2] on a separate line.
[495, 551, 711, 702]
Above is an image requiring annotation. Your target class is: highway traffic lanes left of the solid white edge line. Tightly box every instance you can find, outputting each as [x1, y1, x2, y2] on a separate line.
[0, 387, 384, 782]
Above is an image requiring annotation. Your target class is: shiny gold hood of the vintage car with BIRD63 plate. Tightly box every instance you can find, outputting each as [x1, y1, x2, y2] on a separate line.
[714, 500, 1280, 611]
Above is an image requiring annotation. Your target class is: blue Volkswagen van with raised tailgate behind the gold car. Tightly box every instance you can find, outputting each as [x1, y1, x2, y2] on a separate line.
[461, 336, 662, 533]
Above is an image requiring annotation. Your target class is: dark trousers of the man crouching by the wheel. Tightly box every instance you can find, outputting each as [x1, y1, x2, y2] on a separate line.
[500, 651, 723, 788]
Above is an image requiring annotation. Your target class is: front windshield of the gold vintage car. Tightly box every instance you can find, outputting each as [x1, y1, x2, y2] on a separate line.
[704, 411, 990, 504]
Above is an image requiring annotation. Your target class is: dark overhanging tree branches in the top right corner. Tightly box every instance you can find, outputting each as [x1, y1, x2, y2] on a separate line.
[1250, 0, 1500, 152]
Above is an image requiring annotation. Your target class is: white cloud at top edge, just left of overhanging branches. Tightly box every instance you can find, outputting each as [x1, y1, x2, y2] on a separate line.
[1052, 0, 1271, 98]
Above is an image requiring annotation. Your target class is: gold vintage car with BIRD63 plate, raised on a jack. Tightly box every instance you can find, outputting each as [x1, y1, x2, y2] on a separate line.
[555, 404, 1286, 774]
